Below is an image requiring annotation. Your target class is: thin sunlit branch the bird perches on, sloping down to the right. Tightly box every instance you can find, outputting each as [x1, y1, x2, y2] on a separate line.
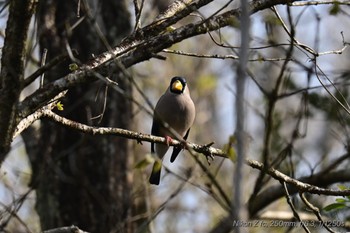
[26, 109, 350, 200]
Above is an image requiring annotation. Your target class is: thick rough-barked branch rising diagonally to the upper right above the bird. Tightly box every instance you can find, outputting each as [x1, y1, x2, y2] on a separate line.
[19, 0, 298, 118]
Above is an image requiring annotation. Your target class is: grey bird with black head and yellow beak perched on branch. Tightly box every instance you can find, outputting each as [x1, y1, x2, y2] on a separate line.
[149, 77, 196, 185]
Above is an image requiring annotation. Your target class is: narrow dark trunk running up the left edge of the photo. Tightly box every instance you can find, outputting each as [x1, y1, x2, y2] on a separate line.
[0, 0, 35, 158]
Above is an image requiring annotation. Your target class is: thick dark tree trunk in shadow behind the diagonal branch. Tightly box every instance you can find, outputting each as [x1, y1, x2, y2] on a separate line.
[25, 0, 132, 232]
